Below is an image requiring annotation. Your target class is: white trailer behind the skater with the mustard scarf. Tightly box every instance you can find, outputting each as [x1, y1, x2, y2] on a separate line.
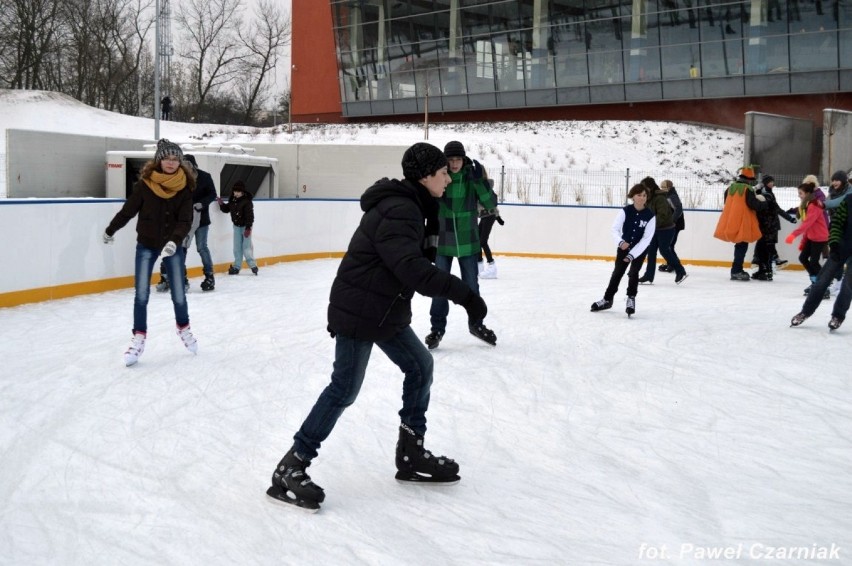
[106, 144, 278, 199]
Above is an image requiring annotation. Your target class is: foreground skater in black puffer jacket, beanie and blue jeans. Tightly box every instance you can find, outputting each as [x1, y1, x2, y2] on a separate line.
[266, 143, 487, 511]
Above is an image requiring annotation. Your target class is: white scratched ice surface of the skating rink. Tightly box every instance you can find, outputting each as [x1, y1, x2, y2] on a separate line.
[0, 258, 852, 566]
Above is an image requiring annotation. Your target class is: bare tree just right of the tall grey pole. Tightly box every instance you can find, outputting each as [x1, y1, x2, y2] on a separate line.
[177, 0, 245, 119]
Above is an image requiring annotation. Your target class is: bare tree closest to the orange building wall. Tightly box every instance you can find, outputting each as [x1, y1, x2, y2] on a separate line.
[239, 0, 290, 124]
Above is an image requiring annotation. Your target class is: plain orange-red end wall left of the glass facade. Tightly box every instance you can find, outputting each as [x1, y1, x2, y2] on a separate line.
[290, 0, 343, 123]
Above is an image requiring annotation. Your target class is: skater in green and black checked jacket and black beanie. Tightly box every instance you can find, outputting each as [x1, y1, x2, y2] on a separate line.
[425, 141, 497, 350]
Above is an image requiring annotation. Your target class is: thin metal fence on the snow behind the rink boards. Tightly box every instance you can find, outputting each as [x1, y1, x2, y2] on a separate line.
[491, 167, 801, 214]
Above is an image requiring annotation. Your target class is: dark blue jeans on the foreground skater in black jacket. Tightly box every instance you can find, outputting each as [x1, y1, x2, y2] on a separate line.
[293, 326, 434, 460]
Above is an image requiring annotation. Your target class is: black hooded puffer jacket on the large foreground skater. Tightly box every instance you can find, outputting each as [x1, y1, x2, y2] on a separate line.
[328, 178, 472, 342]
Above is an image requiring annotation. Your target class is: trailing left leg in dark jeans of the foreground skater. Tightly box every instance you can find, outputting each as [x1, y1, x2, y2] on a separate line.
[293, 334, 373, 460]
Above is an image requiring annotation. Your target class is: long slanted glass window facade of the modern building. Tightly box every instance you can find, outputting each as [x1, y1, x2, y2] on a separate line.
[331, 0, 852, 116]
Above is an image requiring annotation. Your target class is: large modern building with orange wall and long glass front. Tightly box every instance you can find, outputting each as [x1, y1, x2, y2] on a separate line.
[292, 0, 852, 128]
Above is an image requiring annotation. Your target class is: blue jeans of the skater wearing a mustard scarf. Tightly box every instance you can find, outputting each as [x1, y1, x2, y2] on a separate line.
[133, 243, 189, 332]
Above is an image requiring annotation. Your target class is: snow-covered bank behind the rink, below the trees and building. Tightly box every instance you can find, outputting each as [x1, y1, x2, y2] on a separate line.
[0, 89, 744, 200]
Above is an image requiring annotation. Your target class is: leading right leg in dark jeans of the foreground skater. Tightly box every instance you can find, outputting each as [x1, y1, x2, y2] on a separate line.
[376, 328, 436, 435]
